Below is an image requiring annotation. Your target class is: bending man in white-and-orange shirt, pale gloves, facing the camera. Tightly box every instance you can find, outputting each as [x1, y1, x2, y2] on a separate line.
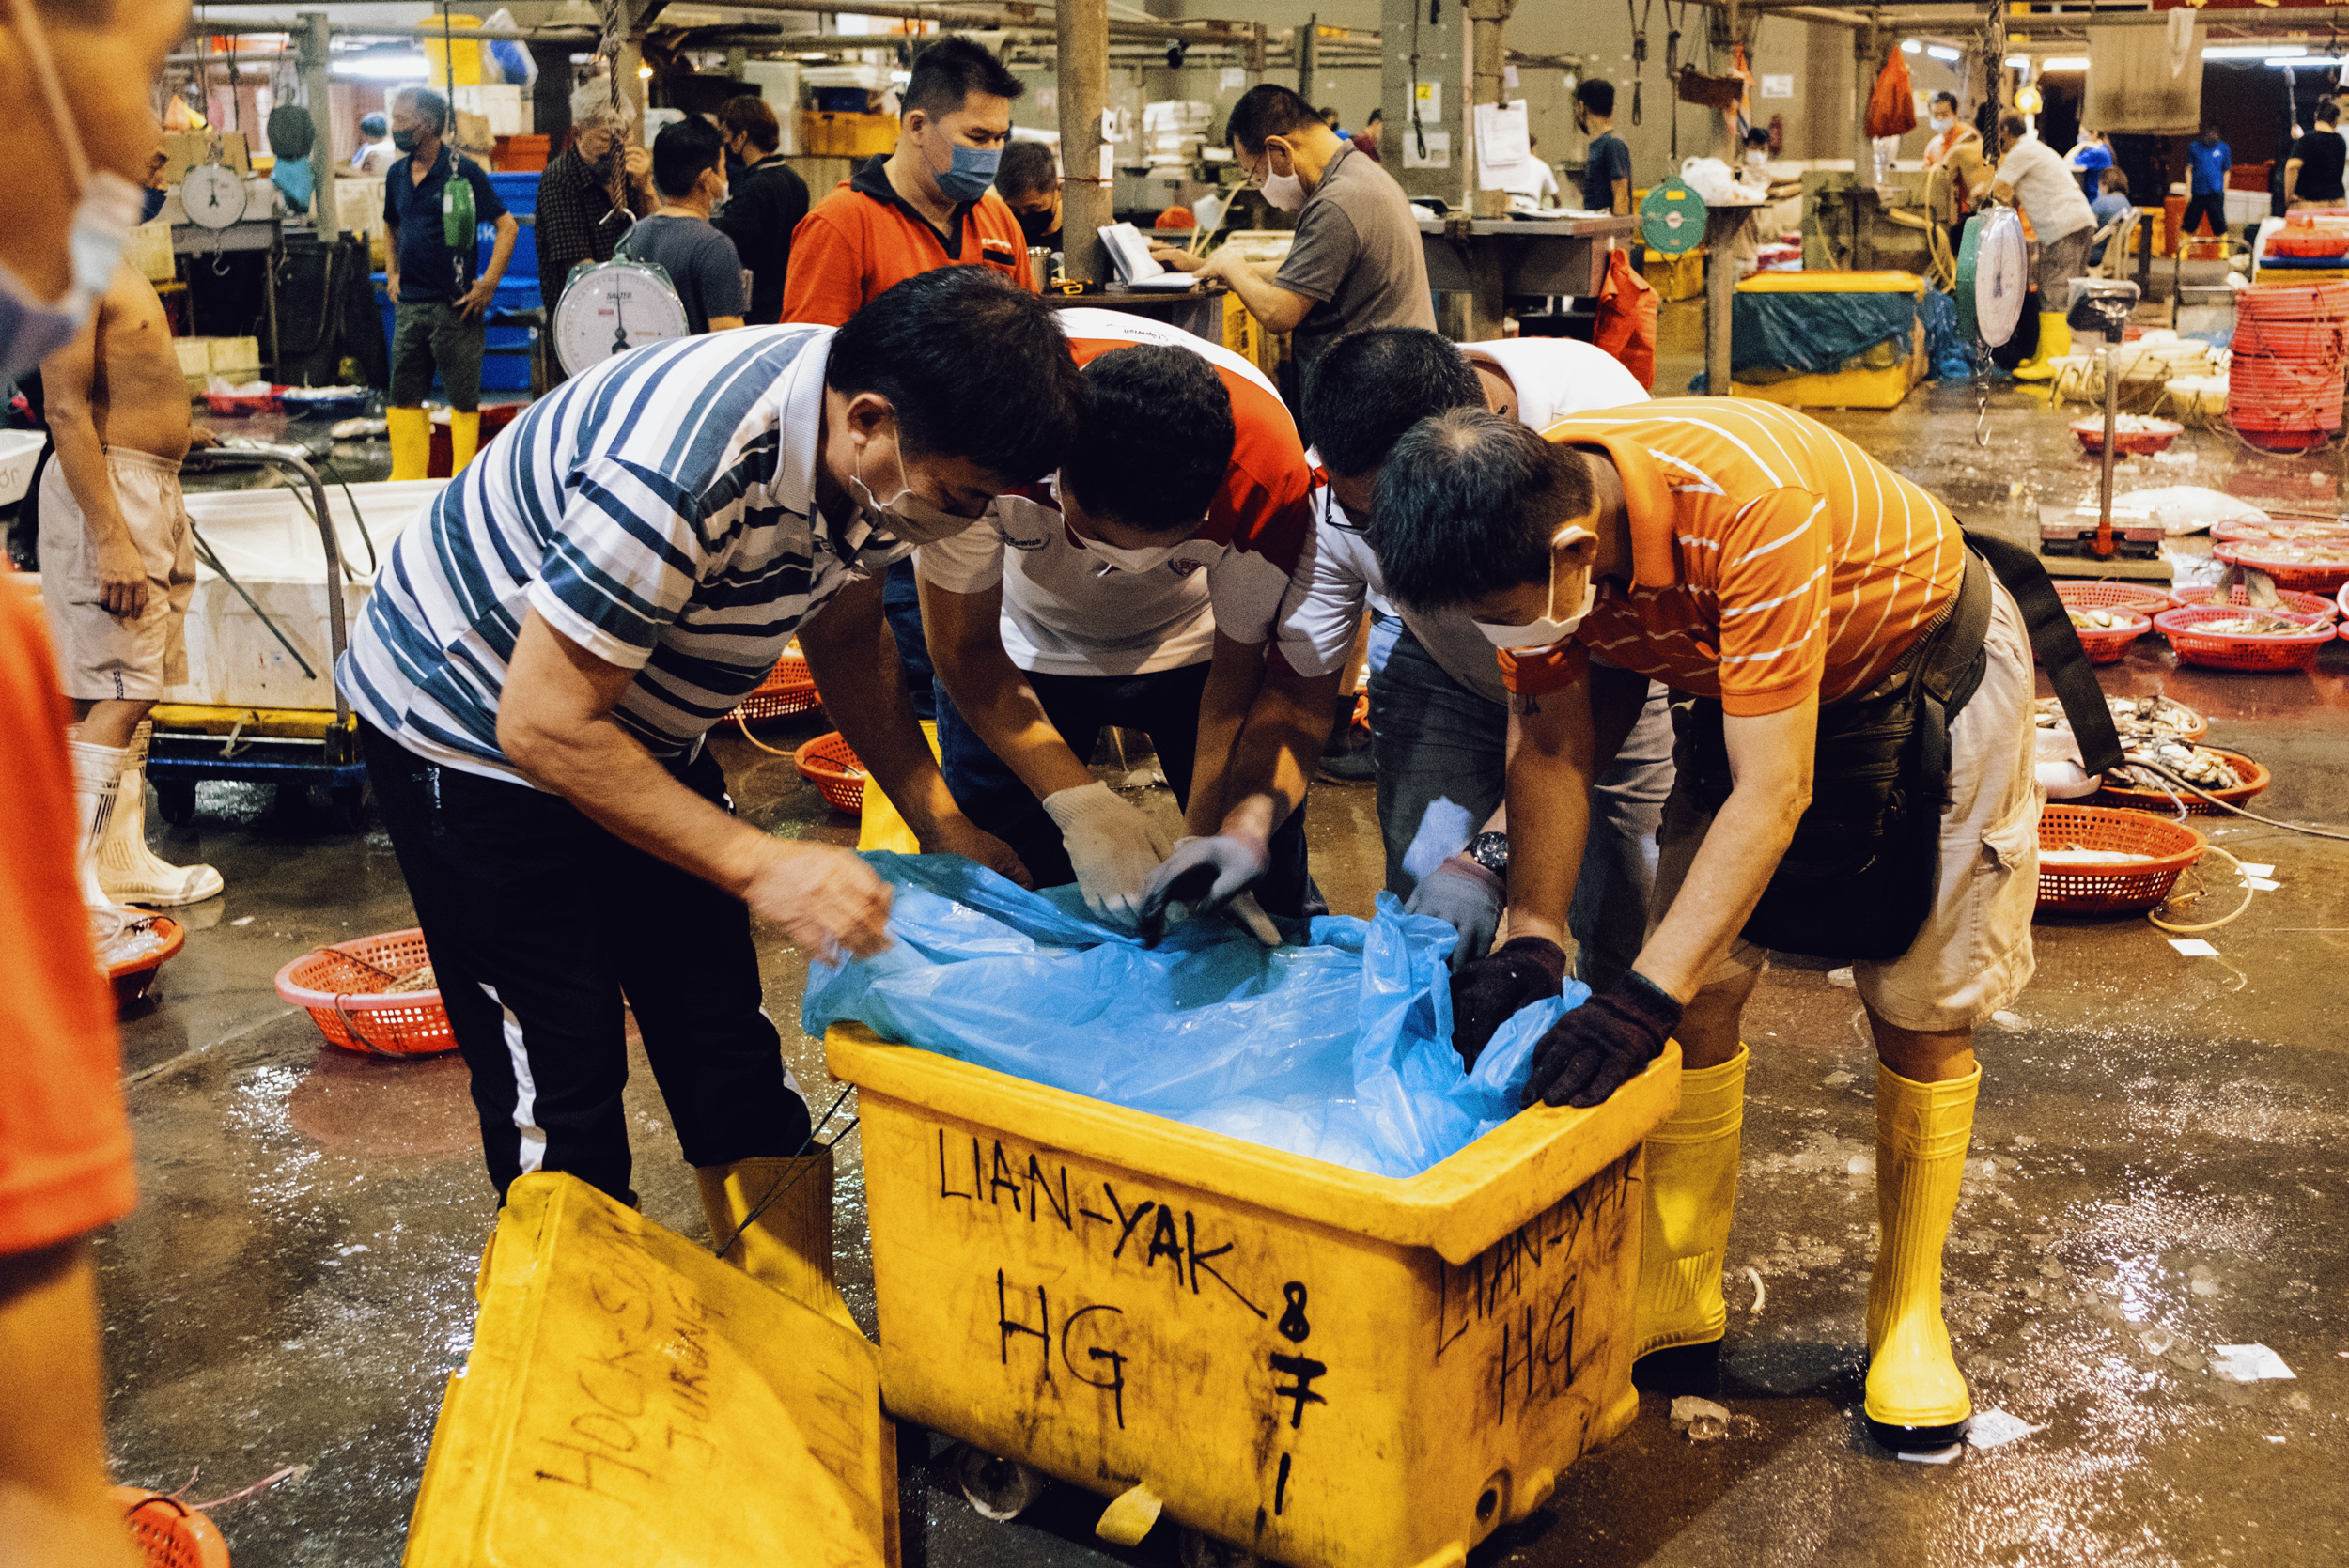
[919, 310, 1353, 941]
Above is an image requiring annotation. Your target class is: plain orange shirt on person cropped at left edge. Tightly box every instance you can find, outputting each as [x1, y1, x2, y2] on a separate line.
[0, 564, 134, 1253]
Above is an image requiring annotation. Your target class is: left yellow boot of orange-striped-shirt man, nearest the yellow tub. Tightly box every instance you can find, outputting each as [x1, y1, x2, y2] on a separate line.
[1630, 1045, 1748, 1394]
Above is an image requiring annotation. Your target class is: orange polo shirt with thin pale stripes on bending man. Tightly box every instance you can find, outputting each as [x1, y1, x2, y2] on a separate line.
[1501, 396, 1967, 716]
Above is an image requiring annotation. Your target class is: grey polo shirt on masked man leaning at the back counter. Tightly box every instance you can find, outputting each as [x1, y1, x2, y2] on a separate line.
[1273, 146, 1436, 373]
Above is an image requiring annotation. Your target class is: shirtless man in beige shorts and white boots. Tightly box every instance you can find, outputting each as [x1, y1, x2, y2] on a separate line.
[40, 150, 221, 906]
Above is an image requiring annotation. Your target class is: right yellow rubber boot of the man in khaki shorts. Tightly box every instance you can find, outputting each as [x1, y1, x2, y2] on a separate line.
[1865, 1063, 1983, 1451]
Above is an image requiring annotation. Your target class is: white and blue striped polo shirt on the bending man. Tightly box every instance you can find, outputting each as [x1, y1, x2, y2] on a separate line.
[336, 326, 910, 784]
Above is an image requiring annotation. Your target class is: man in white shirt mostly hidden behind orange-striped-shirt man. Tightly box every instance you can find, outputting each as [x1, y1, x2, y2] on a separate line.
[1283, 326, 1672, 988]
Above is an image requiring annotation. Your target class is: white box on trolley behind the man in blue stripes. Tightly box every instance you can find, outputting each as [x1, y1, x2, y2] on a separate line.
[164, 479, 446, 709]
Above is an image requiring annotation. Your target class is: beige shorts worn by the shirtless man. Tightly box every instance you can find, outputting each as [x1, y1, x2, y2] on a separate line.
[40, 446, 195, 702]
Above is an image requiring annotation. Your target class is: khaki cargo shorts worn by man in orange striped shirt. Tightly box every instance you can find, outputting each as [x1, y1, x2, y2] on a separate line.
[1649, 582, 2044, 1032]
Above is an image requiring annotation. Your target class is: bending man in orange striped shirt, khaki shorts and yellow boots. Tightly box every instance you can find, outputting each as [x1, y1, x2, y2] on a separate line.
[1370, 399, 2039, 1449]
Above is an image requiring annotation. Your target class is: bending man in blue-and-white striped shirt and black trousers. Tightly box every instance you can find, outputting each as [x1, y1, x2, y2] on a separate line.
[336, 268, 1083, 1261]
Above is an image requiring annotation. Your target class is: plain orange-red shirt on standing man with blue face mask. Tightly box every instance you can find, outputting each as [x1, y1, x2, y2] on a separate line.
[783, 157, 1036, 326]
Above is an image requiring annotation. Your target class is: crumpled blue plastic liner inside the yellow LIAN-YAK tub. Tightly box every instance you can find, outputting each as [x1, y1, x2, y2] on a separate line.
[799, 854, 1591, 1176]
